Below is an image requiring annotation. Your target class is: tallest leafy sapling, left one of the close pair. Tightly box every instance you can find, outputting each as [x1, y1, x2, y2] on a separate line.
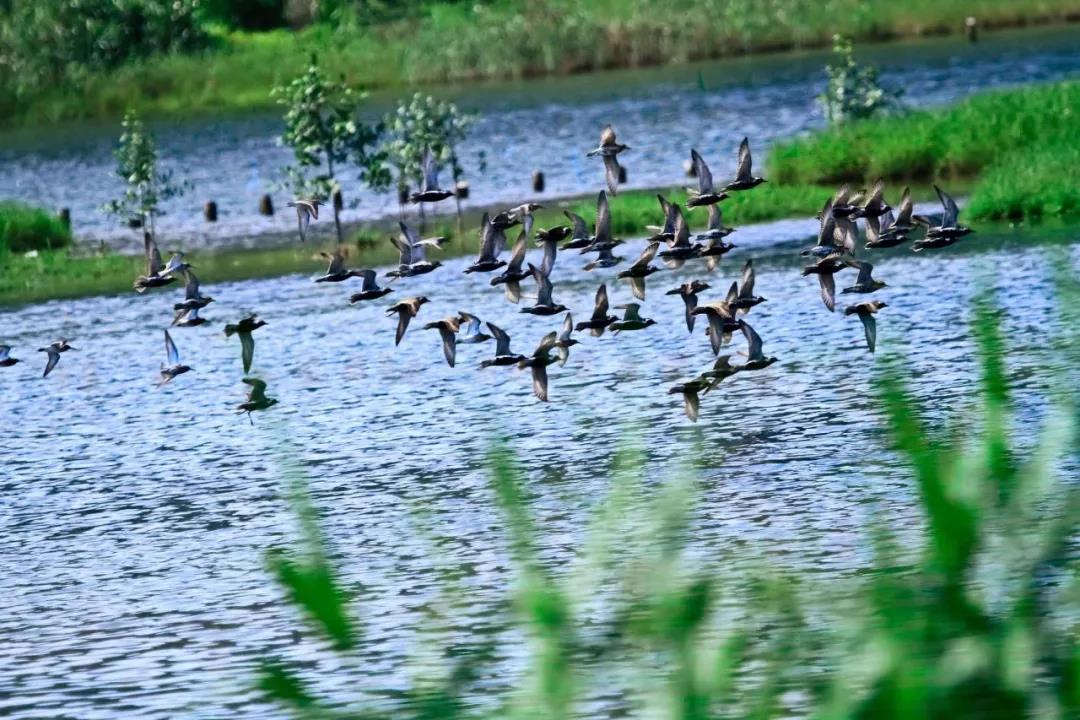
[273, 55, 390, 243]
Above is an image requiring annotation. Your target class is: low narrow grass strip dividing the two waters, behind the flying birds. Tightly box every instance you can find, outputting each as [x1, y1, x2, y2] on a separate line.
[0, 185, 851, 305]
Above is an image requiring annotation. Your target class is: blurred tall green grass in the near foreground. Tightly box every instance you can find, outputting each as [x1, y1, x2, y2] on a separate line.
[259, 281, 1080, 720]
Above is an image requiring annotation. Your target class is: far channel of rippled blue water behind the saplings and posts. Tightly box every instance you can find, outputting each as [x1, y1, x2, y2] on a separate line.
[0, 28, 1080, 249]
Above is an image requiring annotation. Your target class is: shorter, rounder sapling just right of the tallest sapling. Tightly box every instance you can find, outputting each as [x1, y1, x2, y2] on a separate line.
[386, 93, 483, 227]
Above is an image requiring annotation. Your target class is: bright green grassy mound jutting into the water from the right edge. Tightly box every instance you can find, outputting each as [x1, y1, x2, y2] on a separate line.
[768, 81, 1080, 220]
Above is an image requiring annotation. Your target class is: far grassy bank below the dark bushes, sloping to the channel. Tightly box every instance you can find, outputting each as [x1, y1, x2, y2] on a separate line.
[0, 0, 1080, 124]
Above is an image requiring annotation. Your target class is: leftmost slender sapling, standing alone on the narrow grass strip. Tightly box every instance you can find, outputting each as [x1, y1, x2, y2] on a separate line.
[102, 110, 188, 235]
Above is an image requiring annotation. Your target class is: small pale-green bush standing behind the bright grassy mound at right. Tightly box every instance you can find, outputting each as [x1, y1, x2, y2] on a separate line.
[818, 35, 902, 124]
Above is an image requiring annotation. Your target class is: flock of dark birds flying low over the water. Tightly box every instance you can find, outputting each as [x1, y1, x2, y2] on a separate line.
[0, 125, 972, 421]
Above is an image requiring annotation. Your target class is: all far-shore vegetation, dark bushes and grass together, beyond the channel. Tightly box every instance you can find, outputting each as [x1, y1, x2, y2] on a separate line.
[0, 0, 1076, 122]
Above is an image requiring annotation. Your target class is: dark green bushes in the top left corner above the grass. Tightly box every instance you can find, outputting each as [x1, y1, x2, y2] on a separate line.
[0, 0, 208, 102]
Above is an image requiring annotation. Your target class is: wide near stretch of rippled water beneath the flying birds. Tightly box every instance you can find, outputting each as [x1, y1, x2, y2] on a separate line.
[6, 211, 1080, 719]
